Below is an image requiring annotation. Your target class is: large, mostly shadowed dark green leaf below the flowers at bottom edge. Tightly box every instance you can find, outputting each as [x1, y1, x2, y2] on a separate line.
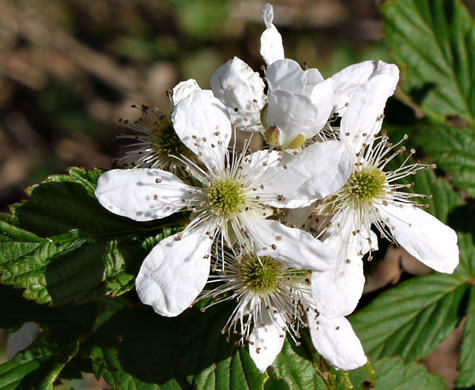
[90, 305, 267, 390]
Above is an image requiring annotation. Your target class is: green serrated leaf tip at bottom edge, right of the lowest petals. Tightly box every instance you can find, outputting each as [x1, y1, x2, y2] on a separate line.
[350, 358, 448, 390]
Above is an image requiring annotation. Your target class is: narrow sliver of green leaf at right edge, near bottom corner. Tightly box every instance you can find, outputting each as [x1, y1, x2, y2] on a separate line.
[456, 286, 475, 388]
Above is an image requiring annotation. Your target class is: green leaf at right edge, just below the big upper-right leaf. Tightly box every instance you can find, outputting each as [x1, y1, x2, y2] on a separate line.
[416, 125, 475, 197]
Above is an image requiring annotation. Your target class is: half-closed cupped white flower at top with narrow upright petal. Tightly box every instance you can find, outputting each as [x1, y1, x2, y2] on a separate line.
[261, 4, 334, 149]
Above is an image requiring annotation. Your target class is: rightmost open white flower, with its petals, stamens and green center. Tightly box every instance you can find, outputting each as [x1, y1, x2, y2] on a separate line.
[312, 84, 459, 313]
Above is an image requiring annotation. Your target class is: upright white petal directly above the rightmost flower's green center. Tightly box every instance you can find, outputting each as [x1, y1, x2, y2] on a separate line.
[340, 87, 384, 153]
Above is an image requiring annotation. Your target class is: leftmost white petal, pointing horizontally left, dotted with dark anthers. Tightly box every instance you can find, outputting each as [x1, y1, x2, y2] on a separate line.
[95, 169, 196, 221]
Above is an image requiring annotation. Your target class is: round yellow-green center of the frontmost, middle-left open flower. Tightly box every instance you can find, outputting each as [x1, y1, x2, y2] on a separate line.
[208, 177, 245, 216]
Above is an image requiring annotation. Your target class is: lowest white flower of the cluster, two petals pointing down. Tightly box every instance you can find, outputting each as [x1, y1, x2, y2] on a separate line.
[202, 248, 367, 372]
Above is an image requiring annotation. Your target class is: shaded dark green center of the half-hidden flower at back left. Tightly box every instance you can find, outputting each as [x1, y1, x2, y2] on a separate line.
[151, 117, 188, 156]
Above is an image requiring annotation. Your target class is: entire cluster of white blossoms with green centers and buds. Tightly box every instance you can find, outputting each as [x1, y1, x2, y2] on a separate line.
[96, 4, 458, 371]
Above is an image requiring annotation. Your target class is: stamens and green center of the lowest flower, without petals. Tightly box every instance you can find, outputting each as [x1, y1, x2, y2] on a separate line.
[200, 251, 311, 345]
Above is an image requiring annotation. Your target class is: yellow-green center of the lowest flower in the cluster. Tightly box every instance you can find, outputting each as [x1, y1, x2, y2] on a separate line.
[241, 255, 284, 295]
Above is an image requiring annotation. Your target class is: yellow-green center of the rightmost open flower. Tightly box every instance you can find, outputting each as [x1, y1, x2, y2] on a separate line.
[346, 168, 386, 202]
